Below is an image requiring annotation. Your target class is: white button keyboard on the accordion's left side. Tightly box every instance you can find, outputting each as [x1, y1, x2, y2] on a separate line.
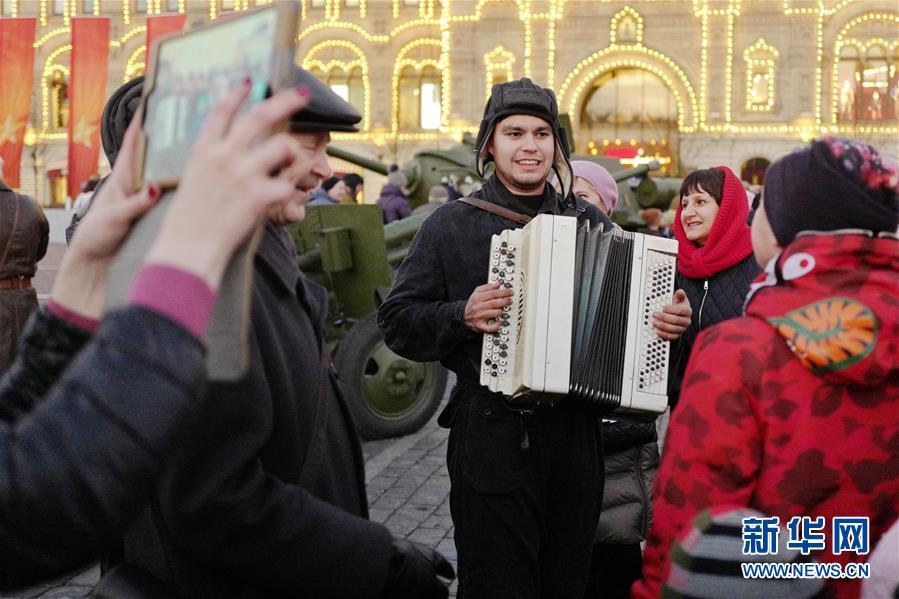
[481, 230, 522, 394]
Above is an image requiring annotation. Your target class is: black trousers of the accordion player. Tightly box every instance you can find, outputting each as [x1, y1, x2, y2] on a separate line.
[447, 387, 603, 599]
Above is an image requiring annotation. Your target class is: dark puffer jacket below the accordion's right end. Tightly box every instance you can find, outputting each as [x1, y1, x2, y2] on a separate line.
[596, 419, 659, 545]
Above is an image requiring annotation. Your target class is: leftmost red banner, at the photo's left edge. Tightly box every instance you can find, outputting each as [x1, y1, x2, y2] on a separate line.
[0, 18, 37, 187]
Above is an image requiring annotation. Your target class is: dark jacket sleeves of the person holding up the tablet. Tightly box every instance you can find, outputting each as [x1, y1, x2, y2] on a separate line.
[0, 307, 204, 589]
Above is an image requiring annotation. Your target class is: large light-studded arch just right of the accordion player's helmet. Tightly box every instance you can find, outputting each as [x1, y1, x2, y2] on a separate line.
[559, 45, 699, 133]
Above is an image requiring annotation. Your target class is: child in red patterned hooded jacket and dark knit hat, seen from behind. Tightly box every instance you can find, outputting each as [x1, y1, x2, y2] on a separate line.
[632, 138, 899, 598]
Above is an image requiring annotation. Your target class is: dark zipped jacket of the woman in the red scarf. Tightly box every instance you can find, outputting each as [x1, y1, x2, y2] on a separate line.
[668, 254, 762, 407]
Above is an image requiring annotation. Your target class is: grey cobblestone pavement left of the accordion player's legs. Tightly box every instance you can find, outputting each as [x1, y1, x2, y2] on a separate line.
[0, 374, 456, 599]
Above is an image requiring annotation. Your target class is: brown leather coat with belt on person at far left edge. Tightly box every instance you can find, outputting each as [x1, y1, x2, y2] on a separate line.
[0, 181, 50, 373]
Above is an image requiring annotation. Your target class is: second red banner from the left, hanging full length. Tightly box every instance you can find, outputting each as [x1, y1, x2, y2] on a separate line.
[68, 17, 109, 198]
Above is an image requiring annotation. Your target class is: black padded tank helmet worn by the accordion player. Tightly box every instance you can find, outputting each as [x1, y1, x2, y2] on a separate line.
[475, 77, 574, 199]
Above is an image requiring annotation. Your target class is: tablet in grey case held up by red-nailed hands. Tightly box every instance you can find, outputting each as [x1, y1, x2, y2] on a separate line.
[106, 0, 300, 381]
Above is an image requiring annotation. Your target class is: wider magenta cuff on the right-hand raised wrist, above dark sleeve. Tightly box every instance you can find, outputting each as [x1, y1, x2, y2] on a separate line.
[128, 264, 215, 339]
